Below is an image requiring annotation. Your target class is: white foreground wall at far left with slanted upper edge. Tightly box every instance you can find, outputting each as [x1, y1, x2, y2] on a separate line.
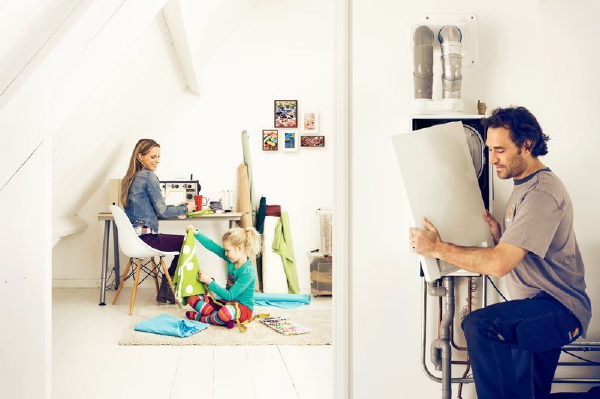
[0, 1, 169, 399]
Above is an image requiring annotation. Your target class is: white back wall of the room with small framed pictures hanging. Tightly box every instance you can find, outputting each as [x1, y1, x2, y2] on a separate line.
[139, 1, 335, 292]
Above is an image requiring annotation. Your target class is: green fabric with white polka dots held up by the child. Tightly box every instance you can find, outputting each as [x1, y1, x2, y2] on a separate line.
[173, 230, 206, 306]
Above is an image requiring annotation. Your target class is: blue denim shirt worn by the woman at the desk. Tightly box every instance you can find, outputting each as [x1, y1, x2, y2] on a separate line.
[125, 169, 187, 232]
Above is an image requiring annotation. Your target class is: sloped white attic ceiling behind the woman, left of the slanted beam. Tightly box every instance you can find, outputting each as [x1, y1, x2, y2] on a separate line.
[52, 13, 185, 242]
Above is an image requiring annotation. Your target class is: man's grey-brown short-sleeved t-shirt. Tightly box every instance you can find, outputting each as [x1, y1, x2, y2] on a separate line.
[500, 168, 592, 334]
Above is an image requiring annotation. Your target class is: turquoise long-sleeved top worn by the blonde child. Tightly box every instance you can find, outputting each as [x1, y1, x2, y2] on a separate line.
[195, 232, 256, 310]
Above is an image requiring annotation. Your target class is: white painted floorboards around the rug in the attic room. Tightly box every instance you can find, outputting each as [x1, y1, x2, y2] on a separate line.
[51, 288, 333, 399]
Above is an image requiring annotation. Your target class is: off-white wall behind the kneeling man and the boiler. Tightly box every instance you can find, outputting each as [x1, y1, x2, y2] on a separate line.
[351, 0, 600, 398]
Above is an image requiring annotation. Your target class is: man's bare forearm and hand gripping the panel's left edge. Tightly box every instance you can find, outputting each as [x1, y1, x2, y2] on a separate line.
[410, 218, 527, 277]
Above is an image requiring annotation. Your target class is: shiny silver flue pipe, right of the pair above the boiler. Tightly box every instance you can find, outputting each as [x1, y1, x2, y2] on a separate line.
[438, 25, 462, 98]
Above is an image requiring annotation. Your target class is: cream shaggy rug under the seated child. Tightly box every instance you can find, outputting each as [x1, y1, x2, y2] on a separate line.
[119, 306, 332, 346]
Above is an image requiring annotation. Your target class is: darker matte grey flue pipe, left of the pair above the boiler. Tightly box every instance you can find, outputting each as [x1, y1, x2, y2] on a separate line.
[413, 25, 434, 99]
